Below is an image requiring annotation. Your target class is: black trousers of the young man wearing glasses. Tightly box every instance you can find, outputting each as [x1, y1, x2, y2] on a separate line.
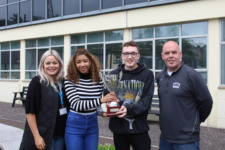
[113, 132, 151, 150]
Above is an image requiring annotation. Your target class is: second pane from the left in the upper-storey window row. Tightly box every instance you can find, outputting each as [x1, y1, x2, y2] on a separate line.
[7, 4, 18, 25]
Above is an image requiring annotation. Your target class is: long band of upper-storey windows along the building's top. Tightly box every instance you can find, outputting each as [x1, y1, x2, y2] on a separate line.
[0, 0, 190, 30]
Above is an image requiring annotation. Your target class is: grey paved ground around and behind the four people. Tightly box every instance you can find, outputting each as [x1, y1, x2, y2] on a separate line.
[0, 102, 225, 150]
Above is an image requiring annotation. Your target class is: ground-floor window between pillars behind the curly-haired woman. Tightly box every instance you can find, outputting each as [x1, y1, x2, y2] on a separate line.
[71, 30, 123, 73]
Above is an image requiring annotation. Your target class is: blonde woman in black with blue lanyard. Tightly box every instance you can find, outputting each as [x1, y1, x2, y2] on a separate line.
[20, 50, 68, 150]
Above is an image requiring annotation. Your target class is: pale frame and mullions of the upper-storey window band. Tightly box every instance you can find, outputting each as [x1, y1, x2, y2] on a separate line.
[0, 0, 192, 30]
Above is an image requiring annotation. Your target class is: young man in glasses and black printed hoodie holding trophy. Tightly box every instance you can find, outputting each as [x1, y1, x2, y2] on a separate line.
[103, 41, 154, 150]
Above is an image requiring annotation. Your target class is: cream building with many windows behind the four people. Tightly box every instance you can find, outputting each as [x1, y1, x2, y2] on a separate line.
[0, 0, 225, 128]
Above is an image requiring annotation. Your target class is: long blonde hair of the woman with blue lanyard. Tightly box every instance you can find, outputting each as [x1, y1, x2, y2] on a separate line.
[38, 50, 64, 91]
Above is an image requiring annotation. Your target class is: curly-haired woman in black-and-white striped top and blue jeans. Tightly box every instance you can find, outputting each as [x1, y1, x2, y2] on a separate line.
[64, 48, 117, 150]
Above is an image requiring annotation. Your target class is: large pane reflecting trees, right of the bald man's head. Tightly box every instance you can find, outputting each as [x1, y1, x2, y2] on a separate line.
[182, 38, 207, 69]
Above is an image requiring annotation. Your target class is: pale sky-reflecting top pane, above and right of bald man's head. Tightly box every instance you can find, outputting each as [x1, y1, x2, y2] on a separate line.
[181, 22, 208, 35]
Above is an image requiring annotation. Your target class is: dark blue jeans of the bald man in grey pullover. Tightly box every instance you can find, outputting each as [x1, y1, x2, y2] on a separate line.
[159, 137, 200, 150]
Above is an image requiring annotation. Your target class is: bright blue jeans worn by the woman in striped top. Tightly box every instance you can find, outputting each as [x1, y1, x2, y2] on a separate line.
[65, 112, 99, 150]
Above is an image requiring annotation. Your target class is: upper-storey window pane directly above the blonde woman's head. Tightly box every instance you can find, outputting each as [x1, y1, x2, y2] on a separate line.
[47, 0, 61, 18]
